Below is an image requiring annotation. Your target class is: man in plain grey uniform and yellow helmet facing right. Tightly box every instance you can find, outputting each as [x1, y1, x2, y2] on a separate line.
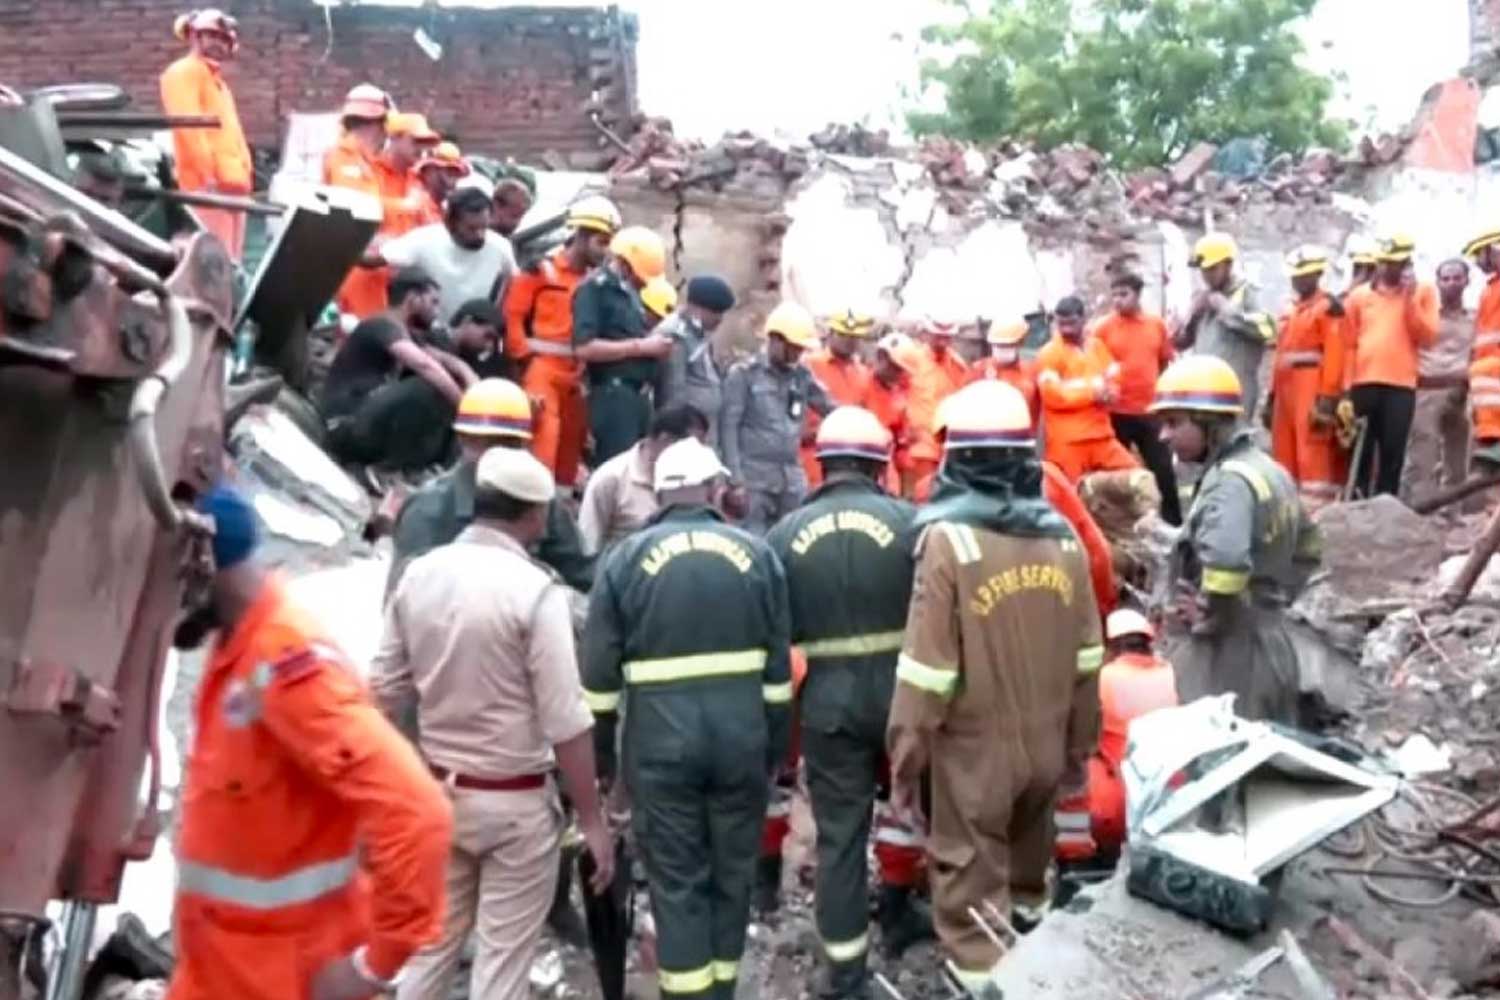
[719, 301, 834, 535]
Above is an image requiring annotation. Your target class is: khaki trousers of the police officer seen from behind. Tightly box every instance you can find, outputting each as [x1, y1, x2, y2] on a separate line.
[396, 783, 563, 1000]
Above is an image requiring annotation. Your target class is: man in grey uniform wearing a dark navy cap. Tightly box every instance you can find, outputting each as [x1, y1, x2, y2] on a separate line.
[656, 274, 735, 451]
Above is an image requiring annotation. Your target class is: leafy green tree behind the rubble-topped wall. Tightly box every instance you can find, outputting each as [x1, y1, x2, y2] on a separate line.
[908, 0, 1349, 168]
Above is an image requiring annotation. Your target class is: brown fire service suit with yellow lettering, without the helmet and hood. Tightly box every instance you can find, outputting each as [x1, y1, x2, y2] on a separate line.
[888, 520, 1104, 978]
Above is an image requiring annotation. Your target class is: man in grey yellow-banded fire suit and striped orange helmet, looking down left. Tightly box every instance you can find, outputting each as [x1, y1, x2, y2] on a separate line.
[1152, 354, 1322, 726]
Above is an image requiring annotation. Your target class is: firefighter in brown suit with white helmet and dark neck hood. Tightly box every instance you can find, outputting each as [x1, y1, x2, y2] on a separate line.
[887, 379, 1104, 996]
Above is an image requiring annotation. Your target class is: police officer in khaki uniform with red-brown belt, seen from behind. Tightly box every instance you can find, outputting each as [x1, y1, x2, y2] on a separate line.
[372, 448, 614, 1000]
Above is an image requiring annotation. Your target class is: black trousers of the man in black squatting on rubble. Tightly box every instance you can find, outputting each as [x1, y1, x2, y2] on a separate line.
[329, 376, 456, 471]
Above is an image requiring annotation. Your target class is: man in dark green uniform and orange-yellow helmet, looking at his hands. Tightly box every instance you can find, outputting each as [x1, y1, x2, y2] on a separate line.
[573, 226, 672, 468]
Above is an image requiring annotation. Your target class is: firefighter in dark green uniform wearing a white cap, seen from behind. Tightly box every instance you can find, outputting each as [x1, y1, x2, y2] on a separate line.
[584, 438, 792, 1000]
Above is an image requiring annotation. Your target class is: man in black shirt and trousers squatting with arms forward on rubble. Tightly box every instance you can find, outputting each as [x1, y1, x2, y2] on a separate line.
[318, 268, 476, 471]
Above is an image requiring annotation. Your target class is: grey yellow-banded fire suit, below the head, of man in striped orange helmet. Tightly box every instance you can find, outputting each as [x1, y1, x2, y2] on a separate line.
[1169, 429, 1322, 724]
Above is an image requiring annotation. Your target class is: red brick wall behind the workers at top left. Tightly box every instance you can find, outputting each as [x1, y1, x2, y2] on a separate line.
[0, 0, 638, 168]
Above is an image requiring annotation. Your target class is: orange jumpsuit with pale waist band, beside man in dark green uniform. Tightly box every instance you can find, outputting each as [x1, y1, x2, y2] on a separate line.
[506, 247, 588, 486]
